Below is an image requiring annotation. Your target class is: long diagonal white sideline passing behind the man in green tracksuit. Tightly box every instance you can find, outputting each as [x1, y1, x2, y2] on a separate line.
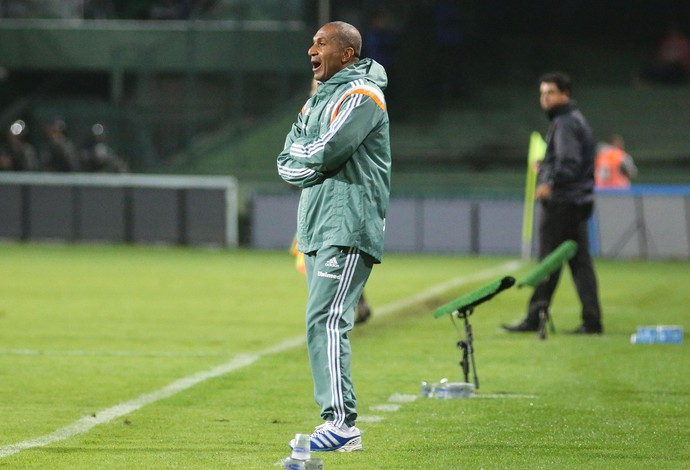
[0, 261, 522, 459]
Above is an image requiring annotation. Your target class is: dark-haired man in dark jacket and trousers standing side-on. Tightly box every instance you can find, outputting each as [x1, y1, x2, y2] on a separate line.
[503, 72, 603, 334]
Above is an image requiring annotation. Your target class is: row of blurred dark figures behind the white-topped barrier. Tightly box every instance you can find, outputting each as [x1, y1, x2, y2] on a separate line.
[0, 118, 129, 173]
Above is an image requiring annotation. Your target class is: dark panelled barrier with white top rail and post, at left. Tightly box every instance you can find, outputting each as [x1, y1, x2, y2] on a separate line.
[0, 173, 238, 247]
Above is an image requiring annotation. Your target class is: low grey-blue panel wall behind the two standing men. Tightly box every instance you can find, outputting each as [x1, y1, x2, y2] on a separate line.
[251, 186, 690, 259]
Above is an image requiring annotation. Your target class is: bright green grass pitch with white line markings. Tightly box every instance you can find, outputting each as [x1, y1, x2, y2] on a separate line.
[0, 244, 690, 469]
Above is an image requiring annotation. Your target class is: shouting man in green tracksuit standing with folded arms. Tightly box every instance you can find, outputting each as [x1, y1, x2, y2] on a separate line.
[278, 21, 391, 452]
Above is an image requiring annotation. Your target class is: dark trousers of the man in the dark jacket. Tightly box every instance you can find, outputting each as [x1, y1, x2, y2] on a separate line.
[527, 201, 601, 328]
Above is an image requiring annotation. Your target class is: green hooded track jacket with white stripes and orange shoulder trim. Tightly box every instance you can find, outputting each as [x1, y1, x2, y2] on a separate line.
[278, 59, 391, 262]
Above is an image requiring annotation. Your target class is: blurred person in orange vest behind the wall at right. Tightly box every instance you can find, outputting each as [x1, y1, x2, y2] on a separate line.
[594, 134, 637, 189]
